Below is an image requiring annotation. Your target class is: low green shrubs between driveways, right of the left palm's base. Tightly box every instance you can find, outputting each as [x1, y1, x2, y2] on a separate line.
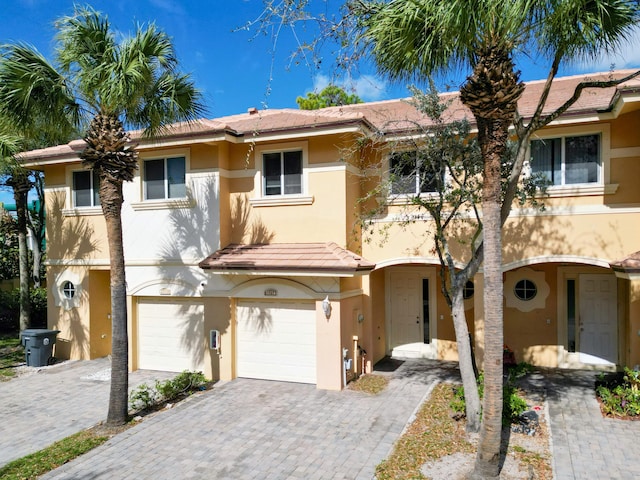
[129, 370, 211, 413]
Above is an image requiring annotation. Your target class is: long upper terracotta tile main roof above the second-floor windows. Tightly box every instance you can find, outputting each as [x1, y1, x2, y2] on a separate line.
[21, 70, 640, 161]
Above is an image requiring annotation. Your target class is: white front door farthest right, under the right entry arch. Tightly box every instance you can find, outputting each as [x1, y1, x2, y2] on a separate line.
[579, 274, 618, 365]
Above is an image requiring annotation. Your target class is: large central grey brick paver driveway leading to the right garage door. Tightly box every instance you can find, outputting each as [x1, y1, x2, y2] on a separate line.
[42, 360, 458, 480]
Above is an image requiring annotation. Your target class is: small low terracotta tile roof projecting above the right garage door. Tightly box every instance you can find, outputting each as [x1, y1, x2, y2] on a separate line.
[199, 242, 375, 274]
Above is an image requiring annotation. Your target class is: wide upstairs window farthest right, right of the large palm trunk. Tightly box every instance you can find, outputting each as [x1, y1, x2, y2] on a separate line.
[530, 135, 601, 185]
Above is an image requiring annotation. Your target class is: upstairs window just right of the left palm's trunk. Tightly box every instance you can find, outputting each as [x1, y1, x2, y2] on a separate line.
[144, 157, 187, 200]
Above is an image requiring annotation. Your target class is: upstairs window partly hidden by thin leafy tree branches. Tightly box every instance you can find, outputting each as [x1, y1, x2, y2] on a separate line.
[389, 151, 444, 195]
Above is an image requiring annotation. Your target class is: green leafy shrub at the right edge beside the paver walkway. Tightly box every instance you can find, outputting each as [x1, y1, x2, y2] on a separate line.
[596, 367, 640, 420]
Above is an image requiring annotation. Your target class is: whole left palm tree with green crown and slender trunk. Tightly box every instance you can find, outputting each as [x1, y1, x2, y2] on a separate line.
[0, 7, 204, 425]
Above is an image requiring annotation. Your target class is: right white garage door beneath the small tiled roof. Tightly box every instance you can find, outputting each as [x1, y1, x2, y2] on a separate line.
[236, 301, 316, 383]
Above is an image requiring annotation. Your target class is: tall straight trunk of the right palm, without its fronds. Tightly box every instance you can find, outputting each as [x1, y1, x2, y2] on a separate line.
[472, 118, 509, 479]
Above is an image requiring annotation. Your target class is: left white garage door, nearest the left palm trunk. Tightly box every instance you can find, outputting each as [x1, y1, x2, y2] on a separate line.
[138, 299, 204, 372]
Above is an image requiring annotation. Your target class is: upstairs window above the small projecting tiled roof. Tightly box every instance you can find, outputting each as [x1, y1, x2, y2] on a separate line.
[262, 150, 302, 196]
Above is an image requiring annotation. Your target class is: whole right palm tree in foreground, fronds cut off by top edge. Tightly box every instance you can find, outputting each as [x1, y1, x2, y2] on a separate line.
[353, 0, 638, 478]
